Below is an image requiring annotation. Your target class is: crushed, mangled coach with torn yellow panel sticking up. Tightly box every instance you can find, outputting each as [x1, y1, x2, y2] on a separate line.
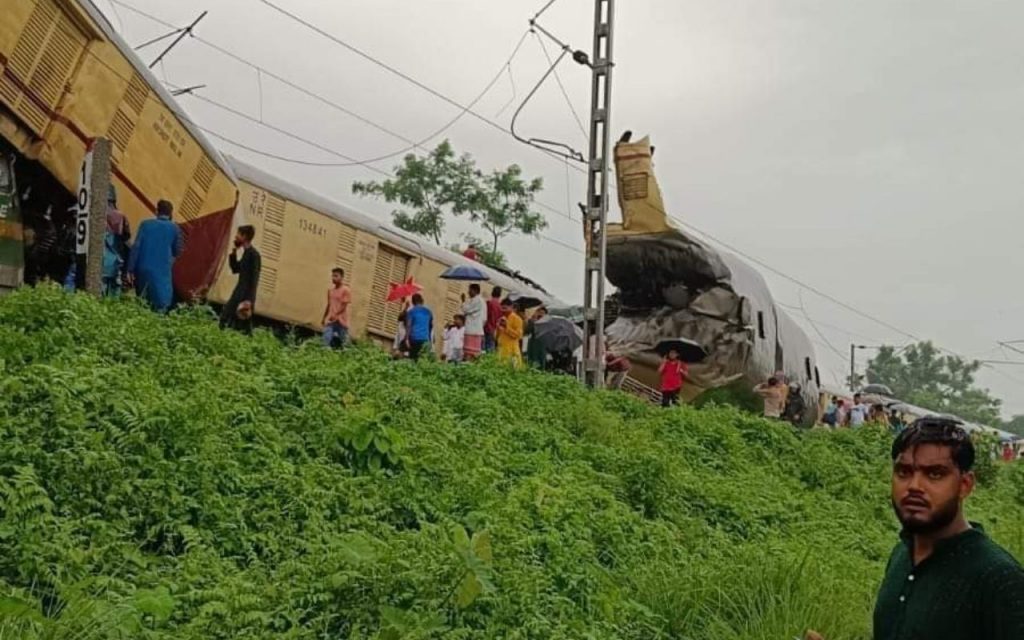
[606, 136, 820, 424]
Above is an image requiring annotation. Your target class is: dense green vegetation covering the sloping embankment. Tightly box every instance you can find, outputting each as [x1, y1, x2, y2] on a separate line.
[0, 289, 1024, 640]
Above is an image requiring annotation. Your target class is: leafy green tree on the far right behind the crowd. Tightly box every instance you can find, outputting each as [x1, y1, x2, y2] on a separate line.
[867, 342, 1002, 426]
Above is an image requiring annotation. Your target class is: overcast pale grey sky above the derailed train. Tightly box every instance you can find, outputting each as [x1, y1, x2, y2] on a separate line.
[95, 0, 1024, 416]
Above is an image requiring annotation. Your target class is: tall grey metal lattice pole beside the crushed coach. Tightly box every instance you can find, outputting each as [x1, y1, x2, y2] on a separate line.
[583, 0, 615, 388]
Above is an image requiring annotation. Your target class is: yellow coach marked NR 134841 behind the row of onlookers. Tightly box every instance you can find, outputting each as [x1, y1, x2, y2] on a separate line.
[209, 157, 560, 352]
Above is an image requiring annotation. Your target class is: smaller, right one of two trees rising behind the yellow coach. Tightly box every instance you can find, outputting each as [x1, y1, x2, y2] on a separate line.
[469, 165, 548, 252]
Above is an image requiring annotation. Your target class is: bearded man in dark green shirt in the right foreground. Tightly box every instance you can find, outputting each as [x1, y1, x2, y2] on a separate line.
[807, 418, 1024, 640]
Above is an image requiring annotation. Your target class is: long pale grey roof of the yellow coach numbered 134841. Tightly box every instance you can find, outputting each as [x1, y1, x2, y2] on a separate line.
[225, 155, 565, 307]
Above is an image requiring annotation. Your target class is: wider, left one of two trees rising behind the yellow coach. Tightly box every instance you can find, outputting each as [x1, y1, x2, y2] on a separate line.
[352, 140, 479, 245]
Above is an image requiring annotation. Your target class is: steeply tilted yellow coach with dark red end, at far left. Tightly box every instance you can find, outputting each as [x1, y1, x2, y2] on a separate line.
[0, 0, 237, 297]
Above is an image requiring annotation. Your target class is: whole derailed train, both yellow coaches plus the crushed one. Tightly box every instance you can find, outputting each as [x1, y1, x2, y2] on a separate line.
[0, 0, 819, 418]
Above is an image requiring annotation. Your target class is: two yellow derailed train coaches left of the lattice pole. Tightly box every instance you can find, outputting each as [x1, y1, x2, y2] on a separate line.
[0, 0, 557, 350]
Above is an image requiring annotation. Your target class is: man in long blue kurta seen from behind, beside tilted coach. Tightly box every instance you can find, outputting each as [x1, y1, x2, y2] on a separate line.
[128, 200, 183, 313]
